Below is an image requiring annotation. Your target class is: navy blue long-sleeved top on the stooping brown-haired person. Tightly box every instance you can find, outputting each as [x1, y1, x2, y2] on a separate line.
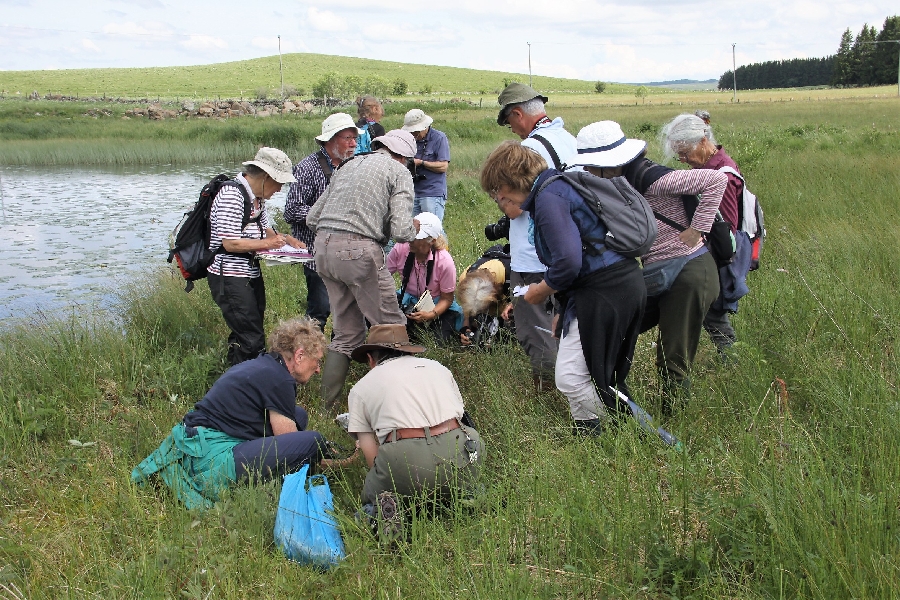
[522, 169, 624, 291]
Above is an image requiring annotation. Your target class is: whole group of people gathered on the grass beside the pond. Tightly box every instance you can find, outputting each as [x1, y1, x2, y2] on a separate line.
[132, 83, 746, 544]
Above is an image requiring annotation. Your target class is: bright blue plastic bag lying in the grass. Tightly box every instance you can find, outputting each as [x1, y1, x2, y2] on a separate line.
[275, 465, 345, 569]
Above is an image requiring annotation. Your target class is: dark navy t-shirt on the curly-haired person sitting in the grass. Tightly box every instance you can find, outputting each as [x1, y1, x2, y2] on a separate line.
[184, 354, 300, 440]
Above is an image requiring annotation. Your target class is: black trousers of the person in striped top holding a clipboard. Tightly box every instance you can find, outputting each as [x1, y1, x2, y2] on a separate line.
[206, 273, 266, 365]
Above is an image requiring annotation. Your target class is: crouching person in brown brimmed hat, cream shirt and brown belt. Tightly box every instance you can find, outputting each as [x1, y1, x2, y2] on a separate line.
[348, 324, 484, 542]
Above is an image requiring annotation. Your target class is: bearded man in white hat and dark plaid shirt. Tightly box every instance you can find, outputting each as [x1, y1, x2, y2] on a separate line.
[284, 113, 360, 331]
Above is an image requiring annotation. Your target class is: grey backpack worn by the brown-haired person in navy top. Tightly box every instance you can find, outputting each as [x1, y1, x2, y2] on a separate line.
[537, 171, 656, 258]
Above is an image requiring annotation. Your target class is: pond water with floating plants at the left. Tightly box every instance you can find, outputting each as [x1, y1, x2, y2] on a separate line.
[0, 164, 287, 325]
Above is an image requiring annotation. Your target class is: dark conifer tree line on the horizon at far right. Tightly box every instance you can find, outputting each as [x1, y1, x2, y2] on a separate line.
[719, 16, 900, 90]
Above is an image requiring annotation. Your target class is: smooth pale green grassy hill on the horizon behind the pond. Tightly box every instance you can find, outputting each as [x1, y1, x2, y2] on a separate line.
[0, 53, 627, 98]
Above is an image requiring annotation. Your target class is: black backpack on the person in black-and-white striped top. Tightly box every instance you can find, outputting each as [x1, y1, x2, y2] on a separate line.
[166, 175, 253, 292]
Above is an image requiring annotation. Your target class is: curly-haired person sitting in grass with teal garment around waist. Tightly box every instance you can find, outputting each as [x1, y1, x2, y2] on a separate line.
[131, 319, 326, 509]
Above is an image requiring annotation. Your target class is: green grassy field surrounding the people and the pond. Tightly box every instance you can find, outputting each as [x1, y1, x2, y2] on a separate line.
[0, 91, 900, 599]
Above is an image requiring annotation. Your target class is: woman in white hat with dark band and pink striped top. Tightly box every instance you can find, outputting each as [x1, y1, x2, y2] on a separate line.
[573, 121, 728, 412]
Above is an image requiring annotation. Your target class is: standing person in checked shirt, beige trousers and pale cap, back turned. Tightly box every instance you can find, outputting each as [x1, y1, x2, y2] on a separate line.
[306, 129, 417, 413]
